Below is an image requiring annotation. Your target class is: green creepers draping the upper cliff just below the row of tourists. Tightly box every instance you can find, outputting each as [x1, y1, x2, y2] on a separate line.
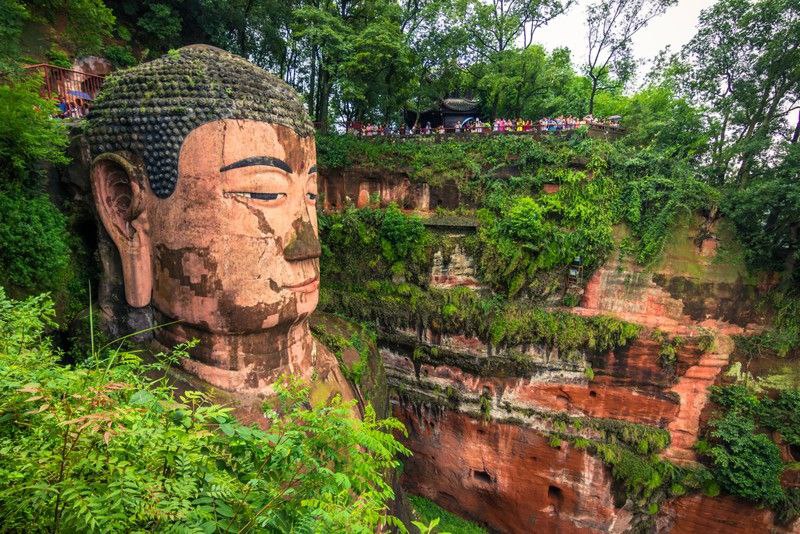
[317, 134, 719, 272]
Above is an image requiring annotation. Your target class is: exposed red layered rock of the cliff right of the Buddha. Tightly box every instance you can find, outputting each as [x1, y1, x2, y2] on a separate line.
[314, 161, 800, 533]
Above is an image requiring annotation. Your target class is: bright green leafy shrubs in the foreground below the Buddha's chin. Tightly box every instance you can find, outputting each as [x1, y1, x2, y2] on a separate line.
[0, 290, 408, 534]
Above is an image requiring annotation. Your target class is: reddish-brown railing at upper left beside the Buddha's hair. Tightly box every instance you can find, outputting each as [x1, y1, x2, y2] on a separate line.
[25, 63, 105, 118]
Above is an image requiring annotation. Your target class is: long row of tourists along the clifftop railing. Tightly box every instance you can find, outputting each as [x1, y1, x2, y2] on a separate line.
[348, 115, 620, 137]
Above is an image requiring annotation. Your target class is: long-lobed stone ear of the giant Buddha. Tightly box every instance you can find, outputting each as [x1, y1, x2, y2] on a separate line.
[91, 153, 153, 308]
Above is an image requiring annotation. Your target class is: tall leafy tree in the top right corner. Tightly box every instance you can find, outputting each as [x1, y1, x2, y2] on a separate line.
[683, 0, 800, 185]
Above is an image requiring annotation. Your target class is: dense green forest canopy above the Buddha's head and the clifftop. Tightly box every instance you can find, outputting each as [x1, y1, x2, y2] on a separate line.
[6, 0, 800, 286]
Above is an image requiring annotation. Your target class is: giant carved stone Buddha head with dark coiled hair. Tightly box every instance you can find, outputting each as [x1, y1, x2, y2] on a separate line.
[88, 46, 320, 340]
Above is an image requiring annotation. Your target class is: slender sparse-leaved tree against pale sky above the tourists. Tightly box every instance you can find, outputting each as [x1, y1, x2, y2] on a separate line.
[585, 0, 677, 114]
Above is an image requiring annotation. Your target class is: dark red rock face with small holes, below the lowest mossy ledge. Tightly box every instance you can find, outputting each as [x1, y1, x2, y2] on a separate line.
[395, 404, 628, 533]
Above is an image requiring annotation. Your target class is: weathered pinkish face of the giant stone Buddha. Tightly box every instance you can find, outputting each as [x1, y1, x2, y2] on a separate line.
[95, 119, 320, 334]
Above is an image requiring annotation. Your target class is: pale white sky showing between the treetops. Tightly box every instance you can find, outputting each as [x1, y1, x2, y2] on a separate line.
[534, 0, 716, 79]
